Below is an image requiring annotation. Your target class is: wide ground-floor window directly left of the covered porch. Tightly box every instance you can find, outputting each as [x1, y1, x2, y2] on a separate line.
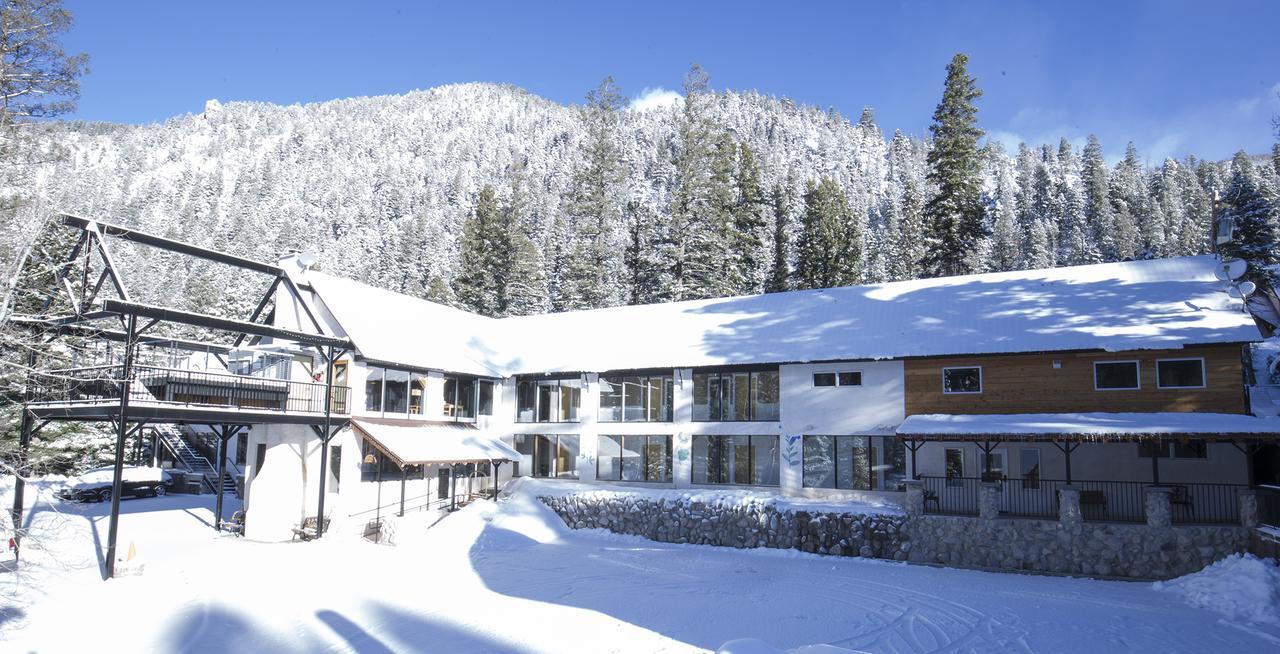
[801, 435, 906, 490]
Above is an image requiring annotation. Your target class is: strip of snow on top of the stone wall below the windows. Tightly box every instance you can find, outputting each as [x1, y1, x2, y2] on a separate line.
[508, 477, 905, 516]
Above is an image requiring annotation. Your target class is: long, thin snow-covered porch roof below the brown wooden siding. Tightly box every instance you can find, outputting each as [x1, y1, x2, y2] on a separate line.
[897, 412, 1280, 440]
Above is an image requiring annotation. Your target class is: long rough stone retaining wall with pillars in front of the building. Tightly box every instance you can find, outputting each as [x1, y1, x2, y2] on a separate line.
[538, 485, 1252, 578]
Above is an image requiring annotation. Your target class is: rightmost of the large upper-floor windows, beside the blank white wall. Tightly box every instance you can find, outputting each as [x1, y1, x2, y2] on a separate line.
[694, 367, 778, 422]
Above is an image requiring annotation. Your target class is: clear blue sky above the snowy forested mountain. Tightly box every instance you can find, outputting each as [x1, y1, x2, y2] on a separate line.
[64, 0, 1280, 161]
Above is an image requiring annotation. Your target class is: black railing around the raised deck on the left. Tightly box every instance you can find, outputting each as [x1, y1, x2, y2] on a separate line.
[32, 366, 351, 415]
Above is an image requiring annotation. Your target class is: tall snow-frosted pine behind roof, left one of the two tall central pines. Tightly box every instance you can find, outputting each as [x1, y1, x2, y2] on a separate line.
[561, 77, 625, 310]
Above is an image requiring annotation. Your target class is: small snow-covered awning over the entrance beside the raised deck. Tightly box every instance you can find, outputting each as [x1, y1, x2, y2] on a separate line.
[351, 417, 520, 466]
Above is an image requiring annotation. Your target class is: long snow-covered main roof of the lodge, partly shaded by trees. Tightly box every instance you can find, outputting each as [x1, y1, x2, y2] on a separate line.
[311, 256, 1261, 375]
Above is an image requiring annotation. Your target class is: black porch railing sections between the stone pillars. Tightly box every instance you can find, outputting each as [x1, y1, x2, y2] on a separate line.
[920, 476, 1244, 525]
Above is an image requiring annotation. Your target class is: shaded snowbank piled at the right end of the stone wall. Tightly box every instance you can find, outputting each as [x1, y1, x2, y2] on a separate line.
[1155, 554, 1280, 625]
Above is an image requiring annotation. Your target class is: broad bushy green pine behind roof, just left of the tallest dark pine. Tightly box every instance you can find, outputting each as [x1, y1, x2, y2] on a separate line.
[796, 177, 863, 288]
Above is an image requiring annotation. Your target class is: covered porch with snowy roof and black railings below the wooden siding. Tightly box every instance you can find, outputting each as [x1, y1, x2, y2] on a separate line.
[897, 413, 1280, 525]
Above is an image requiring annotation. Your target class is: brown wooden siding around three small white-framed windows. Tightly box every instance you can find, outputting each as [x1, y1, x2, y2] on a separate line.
[905, 346, 1247, 416]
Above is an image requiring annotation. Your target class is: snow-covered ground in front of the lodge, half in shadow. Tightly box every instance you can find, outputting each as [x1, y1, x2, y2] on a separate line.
[0, 478, 1280, 654]
